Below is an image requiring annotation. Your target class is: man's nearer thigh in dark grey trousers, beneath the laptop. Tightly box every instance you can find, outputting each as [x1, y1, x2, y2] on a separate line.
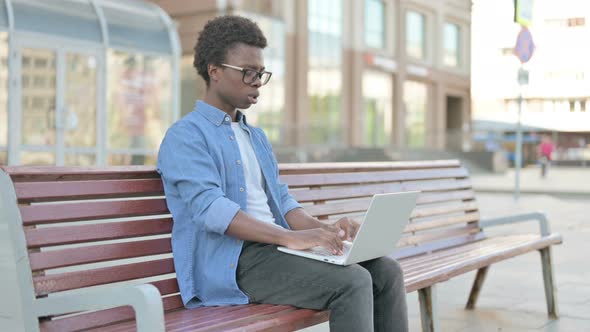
[237, 242, 397, 309]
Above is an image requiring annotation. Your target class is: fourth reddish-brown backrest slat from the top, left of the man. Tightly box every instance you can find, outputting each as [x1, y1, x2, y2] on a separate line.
[25, 218, 173, 248]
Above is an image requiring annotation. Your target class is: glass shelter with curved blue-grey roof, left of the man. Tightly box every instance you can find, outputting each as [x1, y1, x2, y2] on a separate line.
[0, 0, 181, 166]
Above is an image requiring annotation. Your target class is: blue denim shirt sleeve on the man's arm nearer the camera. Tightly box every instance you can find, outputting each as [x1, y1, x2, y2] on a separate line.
[158, 127, 240, 234]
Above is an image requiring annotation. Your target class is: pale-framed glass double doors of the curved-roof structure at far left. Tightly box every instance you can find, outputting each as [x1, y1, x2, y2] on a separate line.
[11, 39, 102, 166]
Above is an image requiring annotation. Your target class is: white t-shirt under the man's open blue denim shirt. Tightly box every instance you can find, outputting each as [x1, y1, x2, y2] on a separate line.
[231, 122, 275, 223]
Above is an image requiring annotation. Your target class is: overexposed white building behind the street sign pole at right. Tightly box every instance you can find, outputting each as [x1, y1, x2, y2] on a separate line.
[472, 0, 590, 165]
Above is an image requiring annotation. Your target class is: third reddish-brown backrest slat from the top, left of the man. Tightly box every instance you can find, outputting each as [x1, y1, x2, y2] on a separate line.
[20, 198, 170, 226]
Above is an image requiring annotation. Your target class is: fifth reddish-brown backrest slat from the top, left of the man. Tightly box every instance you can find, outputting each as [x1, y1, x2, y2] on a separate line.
[29, 238, 172, 271]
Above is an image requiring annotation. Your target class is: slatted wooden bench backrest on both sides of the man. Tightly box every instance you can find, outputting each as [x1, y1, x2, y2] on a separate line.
[2, 161, 482, 331]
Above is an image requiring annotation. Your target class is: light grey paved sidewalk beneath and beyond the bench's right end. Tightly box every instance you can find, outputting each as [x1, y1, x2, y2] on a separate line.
[408, 193, 590, 332]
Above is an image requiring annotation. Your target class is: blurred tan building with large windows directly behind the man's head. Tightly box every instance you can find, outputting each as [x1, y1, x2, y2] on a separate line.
[152, 0, 471, 158]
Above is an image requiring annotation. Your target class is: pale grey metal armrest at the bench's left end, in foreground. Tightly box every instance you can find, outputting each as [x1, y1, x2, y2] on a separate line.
[33, 284, 165, 332]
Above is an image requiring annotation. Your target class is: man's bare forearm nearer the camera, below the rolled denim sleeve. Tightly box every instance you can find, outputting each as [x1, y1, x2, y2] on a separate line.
[225, 210, 289, 245]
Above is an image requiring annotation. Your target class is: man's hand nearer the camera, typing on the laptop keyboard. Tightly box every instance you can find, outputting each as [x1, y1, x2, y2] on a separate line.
[284, 226, 344, 255]
